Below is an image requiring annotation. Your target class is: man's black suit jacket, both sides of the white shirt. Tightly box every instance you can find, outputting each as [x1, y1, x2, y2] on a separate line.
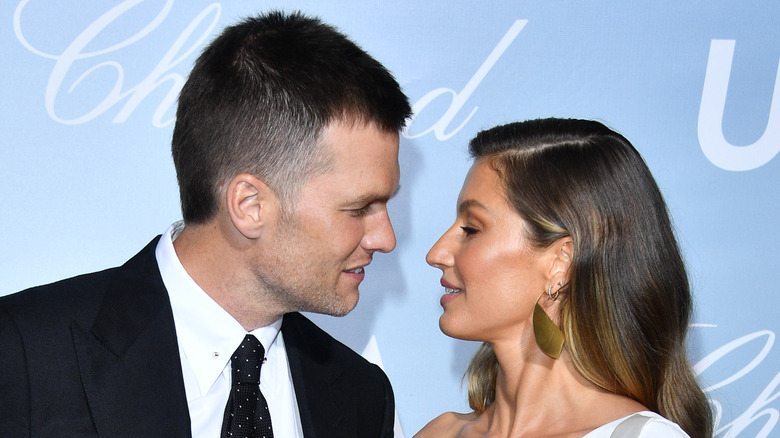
[0, 237, 394, 438]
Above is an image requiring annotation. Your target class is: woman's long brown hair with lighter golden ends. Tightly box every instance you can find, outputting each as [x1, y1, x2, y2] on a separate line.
[467, 119, 712, 437]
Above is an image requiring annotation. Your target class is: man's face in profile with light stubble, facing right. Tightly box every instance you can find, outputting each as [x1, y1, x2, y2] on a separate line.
[255, 123, 400, 316]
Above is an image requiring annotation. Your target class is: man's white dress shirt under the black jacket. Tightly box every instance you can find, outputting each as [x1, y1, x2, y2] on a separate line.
[155, 222, 303, 438]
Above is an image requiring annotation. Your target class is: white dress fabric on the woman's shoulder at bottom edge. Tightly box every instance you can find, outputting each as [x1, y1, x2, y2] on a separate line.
[582, 411, 690, 438]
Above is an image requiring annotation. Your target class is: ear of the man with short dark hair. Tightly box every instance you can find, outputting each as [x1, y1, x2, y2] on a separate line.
[225, 173, 278, 239]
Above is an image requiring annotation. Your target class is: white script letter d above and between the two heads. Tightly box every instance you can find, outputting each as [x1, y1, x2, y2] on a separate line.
[404, 20, 528, 141]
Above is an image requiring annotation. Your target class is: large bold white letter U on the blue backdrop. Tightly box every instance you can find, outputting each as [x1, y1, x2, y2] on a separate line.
[699, 40, 780, 171]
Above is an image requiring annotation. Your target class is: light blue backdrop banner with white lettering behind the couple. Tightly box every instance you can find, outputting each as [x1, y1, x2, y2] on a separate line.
[0, 0, 780, 437]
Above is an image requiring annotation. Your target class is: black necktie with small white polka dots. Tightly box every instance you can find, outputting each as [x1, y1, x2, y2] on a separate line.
[222, 335, 274, 438]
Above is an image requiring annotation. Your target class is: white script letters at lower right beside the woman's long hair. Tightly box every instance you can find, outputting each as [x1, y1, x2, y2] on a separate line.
[694, 324, 780, 438]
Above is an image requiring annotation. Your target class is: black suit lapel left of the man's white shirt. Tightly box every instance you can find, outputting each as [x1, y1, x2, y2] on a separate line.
[71, 239, 190, 437]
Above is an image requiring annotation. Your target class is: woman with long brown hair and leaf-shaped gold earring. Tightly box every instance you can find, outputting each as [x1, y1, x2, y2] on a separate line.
[416, 119, 712, 438]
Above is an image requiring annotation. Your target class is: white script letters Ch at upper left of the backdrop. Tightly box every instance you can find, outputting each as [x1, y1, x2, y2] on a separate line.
[14, 0, 221, 127]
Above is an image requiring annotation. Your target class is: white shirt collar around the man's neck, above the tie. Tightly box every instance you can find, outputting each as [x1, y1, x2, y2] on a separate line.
[155, 222, 282, 394]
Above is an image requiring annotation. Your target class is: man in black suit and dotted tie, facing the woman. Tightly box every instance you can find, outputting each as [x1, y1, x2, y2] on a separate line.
[0, 12, 411, 438]
